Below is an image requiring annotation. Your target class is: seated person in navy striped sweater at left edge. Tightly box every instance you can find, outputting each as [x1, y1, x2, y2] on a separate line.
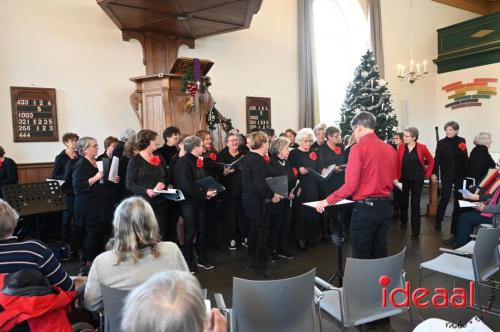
[0, 199, 74, 291]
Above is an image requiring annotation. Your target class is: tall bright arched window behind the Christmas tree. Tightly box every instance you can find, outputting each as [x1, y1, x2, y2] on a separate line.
[313, 0, 369, 124]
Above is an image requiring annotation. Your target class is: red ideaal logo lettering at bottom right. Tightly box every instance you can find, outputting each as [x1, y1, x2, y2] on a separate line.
[378, 275, 474, 308]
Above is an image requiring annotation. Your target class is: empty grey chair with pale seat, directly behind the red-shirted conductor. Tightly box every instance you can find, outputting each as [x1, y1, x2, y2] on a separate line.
[316, 248, 413, 328]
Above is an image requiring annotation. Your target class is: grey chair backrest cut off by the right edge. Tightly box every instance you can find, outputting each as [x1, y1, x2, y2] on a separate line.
[472, 228, 500, 282]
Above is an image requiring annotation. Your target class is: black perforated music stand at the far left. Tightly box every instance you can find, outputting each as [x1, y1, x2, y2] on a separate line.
[2, 181, 67, 239]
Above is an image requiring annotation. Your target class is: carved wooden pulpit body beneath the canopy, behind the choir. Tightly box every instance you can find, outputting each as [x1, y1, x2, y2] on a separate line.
[130, 58, 214, 138]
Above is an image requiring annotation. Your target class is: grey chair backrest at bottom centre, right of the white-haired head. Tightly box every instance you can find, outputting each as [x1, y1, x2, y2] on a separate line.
[231, 269, 318, 332]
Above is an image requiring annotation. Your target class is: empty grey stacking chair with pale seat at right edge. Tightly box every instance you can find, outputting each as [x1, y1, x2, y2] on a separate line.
[419, 228, 500, 316]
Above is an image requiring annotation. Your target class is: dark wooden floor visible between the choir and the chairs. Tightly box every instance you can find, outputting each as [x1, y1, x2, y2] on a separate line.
[64, 199, 500, 331]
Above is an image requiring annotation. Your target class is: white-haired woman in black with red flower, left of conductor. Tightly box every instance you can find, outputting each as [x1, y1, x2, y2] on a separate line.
[288, 128, 320, 251]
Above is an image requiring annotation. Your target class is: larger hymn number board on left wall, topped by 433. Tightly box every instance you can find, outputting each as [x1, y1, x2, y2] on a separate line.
[10, 86, 59, 142]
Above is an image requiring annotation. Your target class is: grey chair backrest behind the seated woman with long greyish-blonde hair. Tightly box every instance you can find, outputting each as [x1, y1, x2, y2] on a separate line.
[101, 284, 130, 332]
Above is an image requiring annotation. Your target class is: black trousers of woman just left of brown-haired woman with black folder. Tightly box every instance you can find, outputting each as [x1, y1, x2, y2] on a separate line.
[223, 194, 248, 244]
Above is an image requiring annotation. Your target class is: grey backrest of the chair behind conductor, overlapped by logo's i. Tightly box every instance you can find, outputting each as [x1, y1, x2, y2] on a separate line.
[342, 247, 406, 326]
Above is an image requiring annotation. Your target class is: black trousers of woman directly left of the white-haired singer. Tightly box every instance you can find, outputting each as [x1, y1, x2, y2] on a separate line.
[270, 200, 291, 253]
